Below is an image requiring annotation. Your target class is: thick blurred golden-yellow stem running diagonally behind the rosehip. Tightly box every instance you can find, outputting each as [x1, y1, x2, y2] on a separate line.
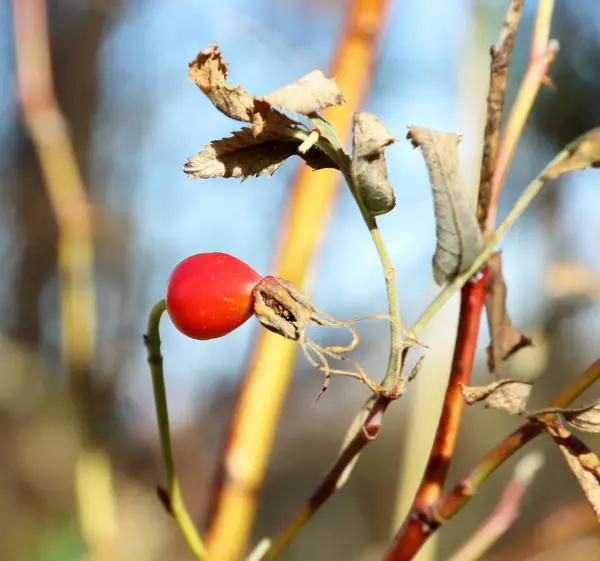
[207, 0, 388, 561]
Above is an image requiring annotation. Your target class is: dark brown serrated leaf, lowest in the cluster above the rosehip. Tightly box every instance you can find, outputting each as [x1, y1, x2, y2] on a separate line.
[183, 127, 335, 181]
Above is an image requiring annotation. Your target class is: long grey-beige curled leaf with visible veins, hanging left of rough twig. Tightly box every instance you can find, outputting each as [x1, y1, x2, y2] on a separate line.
[407, 127, 483, 285]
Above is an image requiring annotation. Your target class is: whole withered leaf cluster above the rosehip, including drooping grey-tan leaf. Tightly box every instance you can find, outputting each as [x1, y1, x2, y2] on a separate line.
[183, 45, 396, 220]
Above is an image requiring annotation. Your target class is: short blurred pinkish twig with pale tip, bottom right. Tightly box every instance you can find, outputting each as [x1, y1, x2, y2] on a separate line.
[448, 452, 544, 561]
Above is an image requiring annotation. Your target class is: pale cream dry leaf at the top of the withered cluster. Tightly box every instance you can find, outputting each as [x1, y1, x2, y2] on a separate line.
[263, 70, 344, 115]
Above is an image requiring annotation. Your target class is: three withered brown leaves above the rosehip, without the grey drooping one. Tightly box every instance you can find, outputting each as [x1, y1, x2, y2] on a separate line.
[183, 45, 344, 180]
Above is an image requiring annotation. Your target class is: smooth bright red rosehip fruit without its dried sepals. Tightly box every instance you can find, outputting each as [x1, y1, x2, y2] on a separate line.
[165, 253, 262, 340]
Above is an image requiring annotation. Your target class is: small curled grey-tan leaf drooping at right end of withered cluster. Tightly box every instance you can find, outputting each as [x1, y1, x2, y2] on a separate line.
[351, 113, 396, 216]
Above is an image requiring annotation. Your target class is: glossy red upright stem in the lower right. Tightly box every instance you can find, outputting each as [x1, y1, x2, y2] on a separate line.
[385, 267, 489, 561]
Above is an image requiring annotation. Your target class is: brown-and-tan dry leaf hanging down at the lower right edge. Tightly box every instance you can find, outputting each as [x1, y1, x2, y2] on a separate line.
[546, 427, 600, 522]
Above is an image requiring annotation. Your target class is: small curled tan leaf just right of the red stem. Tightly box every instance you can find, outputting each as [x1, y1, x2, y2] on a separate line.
[461, 379, 533, 415]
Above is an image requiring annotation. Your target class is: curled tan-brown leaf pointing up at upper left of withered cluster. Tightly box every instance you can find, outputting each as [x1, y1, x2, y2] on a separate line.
[189, 44, 298, 135]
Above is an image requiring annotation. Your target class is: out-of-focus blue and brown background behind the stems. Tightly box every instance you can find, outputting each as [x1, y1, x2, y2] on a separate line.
[0, 0, 600, 561]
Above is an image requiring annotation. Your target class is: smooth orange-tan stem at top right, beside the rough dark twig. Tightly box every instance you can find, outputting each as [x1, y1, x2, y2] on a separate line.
[480, 0, 558, 236]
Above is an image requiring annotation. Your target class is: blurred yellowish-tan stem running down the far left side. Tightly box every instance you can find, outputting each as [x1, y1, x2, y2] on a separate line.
[13, 0, 118, 560]
